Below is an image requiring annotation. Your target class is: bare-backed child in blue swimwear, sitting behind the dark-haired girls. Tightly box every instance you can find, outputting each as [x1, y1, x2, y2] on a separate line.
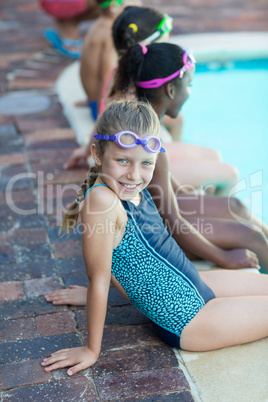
[77, 0, 138, 121]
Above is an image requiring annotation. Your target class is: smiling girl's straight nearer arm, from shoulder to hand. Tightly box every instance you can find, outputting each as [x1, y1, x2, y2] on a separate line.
[42, 187, 118, 375]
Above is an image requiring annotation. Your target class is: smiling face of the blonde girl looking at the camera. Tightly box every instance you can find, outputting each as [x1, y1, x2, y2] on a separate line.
[97, 141, 157, 201]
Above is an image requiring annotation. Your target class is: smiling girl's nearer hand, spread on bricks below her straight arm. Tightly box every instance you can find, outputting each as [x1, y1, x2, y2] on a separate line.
[41, 346, 99, 375]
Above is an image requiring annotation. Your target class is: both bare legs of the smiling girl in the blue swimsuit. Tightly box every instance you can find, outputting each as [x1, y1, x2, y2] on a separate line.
[181, 270, 268, 351]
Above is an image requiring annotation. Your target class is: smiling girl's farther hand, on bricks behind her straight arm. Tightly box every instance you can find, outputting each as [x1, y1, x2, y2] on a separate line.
[45, 285, 87, 306]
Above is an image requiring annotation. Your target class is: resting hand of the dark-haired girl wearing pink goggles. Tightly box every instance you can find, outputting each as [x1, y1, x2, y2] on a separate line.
[222, 248, 260, 269]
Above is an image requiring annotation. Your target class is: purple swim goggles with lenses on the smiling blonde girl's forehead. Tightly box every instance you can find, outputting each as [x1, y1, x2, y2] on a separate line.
[94, 131, 166, 153]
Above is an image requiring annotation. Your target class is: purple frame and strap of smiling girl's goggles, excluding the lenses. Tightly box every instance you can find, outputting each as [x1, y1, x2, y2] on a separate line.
[94, 131, 166, 153]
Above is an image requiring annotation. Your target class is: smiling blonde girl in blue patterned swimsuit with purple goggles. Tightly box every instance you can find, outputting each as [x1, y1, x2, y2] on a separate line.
[41, 99, 268, 375]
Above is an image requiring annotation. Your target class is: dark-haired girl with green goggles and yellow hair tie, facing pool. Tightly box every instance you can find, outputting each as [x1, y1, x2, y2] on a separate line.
[66, 7, 237, 194]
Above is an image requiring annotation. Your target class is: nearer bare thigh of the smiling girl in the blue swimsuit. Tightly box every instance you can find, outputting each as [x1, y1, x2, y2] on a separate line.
[180, 296, 268, 352]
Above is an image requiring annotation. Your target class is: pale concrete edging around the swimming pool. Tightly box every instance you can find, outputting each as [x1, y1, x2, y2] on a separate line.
[56, 32, 268, 402]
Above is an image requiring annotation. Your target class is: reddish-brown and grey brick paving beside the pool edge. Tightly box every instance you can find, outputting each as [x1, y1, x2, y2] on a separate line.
[0, 0, 268, 401]
